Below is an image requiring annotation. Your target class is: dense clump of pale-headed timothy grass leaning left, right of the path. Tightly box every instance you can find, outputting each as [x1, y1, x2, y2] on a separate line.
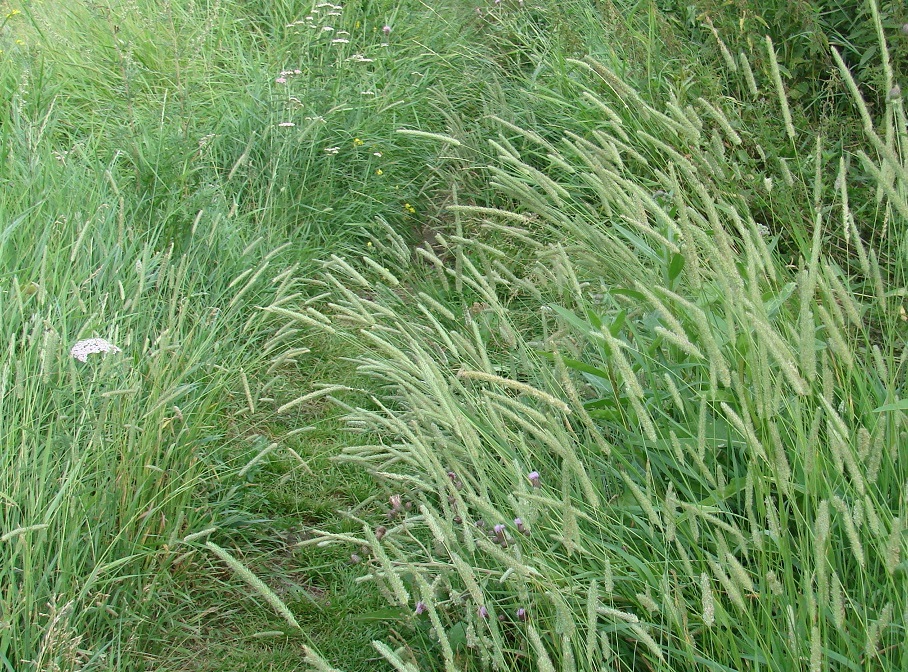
[312, 2, 908, 671]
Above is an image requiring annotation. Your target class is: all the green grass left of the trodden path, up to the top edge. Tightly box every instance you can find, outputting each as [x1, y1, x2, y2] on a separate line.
[0, 0, 560, 670]
